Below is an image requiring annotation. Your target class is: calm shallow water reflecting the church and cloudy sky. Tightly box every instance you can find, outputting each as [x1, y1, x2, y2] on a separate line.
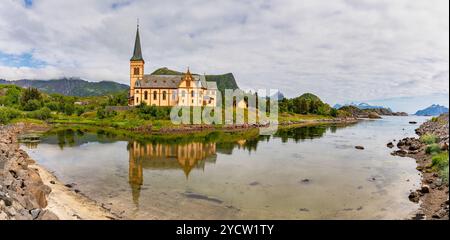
[23, 117, 426, 219]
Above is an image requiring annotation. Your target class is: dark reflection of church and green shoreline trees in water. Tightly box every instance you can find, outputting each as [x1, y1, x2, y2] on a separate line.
[33, 124, 349, 204]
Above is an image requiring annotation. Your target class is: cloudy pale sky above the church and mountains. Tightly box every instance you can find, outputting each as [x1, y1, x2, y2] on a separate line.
[0, 0, 449, 112]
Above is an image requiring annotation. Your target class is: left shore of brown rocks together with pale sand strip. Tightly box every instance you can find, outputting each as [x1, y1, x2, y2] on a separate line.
[0, 124, 121, 220]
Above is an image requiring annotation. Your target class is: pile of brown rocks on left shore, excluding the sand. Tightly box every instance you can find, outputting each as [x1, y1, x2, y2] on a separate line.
[0, 125, 58, 220]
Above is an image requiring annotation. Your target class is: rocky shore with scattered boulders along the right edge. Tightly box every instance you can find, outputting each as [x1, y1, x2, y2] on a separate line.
[387, 113, 449, 220]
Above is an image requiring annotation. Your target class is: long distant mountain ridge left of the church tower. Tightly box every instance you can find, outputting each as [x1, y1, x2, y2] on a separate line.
[0, 78, 129, 97]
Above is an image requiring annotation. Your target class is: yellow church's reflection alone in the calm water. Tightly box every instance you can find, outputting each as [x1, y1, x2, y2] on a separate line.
[128, 141, 216, 204]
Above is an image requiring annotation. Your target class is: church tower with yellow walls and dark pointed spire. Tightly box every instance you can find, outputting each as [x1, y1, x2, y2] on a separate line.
[129, 23, 145, 105]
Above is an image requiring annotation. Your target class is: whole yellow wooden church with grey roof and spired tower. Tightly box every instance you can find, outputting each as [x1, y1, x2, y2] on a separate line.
[128, 25, 217, 107]
